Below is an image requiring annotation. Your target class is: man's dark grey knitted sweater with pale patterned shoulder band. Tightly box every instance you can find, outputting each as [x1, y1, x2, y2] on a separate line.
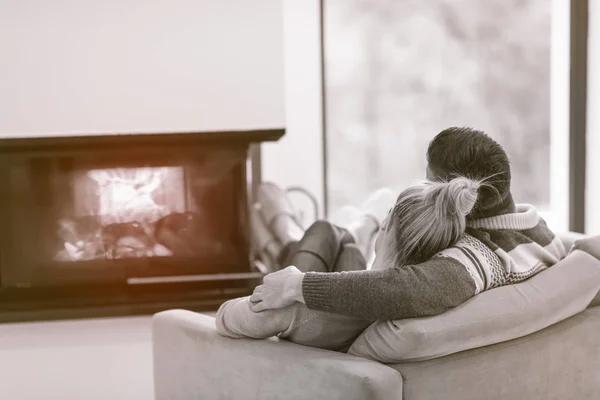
[302, 205, 566, 320]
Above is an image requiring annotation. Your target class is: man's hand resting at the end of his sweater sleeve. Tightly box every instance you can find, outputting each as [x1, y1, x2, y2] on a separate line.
[250, 266, 304, 312]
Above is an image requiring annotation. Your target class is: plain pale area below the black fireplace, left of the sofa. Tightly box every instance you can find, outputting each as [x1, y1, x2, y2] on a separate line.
[0, 317, 211, 400]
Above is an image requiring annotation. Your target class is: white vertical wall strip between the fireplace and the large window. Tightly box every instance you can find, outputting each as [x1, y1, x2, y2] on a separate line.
[263, 0, 324, 216]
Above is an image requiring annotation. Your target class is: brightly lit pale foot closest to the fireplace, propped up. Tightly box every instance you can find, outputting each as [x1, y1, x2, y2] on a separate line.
[257, 182, 304, 246]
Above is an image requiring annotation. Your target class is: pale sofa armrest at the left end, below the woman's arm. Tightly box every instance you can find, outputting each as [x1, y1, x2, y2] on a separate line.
[152, 310, 402, 400]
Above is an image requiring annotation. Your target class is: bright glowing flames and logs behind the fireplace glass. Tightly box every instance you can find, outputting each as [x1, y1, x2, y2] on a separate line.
[53, 167, 196, 261]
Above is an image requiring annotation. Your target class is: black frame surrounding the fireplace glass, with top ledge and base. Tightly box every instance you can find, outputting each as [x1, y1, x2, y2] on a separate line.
[0, 129, 285, 322]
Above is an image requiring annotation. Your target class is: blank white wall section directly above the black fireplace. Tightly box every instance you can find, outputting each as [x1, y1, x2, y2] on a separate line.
[0, 0, 285, 136]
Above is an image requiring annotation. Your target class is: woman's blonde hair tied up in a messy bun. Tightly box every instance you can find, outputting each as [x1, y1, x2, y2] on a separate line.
[386, 177, 482, 265]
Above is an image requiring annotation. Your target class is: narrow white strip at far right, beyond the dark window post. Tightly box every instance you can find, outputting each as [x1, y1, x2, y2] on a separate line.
[585, 0, 600, 234]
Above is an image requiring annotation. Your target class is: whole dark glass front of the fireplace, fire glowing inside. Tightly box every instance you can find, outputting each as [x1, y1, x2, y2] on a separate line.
[0, 144, 250, 287]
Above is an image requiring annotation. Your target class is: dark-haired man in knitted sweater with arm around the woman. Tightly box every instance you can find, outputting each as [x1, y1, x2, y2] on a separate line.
[250, 128, 565, 320]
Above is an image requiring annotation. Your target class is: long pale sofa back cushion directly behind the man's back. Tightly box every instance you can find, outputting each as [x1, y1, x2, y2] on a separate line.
[348, 248, 600, 363]
